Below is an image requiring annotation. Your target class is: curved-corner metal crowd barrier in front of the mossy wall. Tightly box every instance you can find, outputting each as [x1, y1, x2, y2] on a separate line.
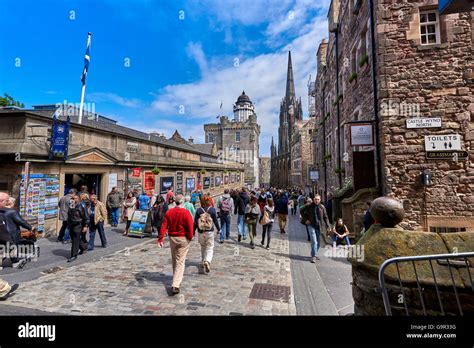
[379, 252, 474, 316]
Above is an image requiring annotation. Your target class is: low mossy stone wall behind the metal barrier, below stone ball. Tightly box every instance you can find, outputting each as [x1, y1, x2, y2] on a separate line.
[348, 224, 474, 315]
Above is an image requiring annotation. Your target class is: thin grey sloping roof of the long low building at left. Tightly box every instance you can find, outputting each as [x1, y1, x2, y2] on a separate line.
[0, 109, 213, 155]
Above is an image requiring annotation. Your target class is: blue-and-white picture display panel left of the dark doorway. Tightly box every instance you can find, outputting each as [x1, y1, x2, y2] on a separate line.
[19, 174, 59, 236]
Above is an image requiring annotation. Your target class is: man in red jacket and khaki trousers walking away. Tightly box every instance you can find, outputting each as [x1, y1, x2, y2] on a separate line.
[158, 195, 194, 295]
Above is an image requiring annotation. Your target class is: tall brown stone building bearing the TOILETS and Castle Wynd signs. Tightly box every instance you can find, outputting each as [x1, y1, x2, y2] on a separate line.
[313, 0, 474, 234]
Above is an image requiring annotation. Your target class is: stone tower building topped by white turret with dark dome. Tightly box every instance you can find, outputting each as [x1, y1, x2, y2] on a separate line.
[204, 91, 260, 187]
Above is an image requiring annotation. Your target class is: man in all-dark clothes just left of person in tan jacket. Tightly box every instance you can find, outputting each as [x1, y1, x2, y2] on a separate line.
[67, 195, 89, 262]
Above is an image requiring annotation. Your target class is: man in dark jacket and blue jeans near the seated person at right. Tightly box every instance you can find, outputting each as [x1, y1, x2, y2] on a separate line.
[301, 195, 331, 263]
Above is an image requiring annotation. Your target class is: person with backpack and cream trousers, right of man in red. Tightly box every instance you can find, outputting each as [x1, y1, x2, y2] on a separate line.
[194, 195, 220, 273]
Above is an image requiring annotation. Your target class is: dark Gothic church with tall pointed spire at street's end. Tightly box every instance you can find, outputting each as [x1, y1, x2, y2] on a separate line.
[270, 52, 303, 187]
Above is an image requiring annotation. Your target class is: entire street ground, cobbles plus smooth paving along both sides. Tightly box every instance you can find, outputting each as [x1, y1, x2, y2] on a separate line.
[0, 212, 353, 315]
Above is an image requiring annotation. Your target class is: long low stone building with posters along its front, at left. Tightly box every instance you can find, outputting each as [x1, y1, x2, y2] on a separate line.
[0, 108, 244, 235]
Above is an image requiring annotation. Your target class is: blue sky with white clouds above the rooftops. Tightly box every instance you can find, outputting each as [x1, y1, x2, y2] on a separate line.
[0, 0, 330, 156]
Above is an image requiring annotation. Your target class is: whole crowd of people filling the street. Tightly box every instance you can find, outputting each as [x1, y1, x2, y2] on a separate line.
[0, 185, 374, 299]
